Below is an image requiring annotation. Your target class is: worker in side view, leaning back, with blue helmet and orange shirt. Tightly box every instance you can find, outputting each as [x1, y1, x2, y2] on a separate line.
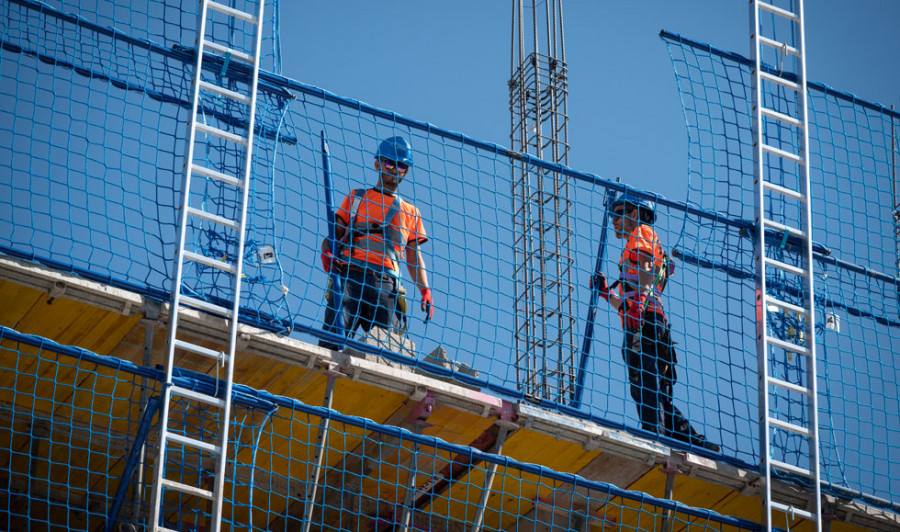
[591, 194, 719, 452]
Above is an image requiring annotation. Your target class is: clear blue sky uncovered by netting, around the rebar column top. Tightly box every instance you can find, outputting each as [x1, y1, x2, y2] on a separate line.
[281, 0, 900, 204]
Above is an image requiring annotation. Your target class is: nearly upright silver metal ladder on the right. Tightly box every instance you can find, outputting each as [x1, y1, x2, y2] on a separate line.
[750, 0, 822, 531]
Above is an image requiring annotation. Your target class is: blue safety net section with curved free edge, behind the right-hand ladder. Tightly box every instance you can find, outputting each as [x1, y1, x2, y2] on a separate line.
[662, 32, 900, 503]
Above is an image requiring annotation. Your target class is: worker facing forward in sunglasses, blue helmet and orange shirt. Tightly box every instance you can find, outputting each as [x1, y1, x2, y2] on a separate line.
[319, 137, 434, 349]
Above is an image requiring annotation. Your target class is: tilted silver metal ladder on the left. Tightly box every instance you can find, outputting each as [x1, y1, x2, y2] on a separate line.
[150, 0, 265, 532]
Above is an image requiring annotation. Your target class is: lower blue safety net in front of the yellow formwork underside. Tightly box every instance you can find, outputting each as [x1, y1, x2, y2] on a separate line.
[0, 327, 759, 531]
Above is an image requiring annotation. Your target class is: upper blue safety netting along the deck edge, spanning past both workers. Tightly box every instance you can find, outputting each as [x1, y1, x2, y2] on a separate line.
[0, 0, 900, 516]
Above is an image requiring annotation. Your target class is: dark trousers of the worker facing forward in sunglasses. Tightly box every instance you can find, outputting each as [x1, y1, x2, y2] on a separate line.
[319, 268, 402, 349]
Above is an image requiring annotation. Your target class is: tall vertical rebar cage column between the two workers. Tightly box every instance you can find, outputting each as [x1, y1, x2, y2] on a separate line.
[509, 0, 577, 404]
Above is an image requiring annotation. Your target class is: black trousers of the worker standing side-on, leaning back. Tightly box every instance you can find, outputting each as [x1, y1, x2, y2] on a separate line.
[622, 310, 704, 444]
